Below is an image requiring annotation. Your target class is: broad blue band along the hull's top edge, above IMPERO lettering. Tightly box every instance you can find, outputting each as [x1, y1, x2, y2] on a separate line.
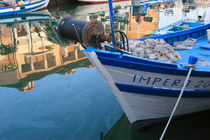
[95, 50, 210, 78]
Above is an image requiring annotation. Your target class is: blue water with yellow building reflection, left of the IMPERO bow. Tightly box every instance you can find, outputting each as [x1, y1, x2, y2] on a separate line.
[0, 10, 122, 140]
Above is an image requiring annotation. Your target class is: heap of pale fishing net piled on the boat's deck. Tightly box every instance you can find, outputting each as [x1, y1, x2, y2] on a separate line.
[129, 39, 181, 63]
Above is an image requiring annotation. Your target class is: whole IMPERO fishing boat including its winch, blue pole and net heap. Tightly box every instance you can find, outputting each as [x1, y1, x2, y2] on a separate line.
[59, 1, 210, 131]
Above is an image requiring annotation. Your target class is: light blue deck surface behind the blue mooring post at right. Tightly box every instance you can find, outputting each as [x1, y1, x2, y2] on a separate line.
[176, 37, 210, 71]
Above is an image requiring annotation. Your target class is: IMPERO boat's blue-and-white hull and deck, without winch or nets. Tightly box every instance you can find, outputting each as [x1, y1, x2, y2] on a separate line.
[81, 24, 210, 125]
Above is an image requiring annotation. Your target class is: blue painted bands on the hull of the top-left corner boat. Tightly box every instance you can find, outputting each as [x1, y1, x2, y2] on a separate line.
[0, 0, 47, 16]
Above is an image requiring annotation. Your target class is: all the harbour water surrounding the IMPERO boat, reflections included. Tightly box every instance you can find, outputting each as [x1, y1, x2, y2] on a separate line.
[0, 0, 210, 140]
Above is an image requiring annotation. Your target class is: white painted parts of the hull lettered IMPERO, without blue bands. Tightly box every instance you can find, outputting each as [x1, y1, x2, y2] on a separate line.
[85, 51, 210, 123]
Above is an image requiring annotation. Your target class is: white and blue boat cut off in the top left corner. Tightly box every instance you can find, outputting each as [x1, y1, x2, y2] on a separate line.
[0, 0, 49, 16]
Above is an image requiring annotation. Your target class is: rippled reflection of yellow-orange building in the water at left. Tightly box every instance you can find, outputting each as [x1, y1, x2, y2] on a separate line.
[0, 10, 91, 92]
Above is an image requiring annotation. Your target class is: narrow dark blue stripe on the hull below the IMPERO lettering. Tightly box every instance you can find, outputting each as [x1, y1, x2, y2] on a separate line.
[115, 83, 210, 98]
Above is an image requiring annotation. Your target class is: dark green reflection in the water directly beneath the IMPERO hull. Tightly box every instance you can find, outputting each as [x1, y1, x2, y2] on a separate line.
[102, 111, 210, 140]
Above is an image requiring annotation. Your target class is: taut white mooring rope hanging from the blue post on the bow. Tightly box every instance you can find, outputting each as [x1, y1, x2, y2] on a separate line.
[159, 60, 198, 140]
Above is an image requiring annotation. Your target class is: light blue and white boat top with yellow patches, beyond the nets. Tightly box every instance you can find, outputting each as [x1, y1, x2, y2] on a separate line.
[152, 17, 208, 35]
